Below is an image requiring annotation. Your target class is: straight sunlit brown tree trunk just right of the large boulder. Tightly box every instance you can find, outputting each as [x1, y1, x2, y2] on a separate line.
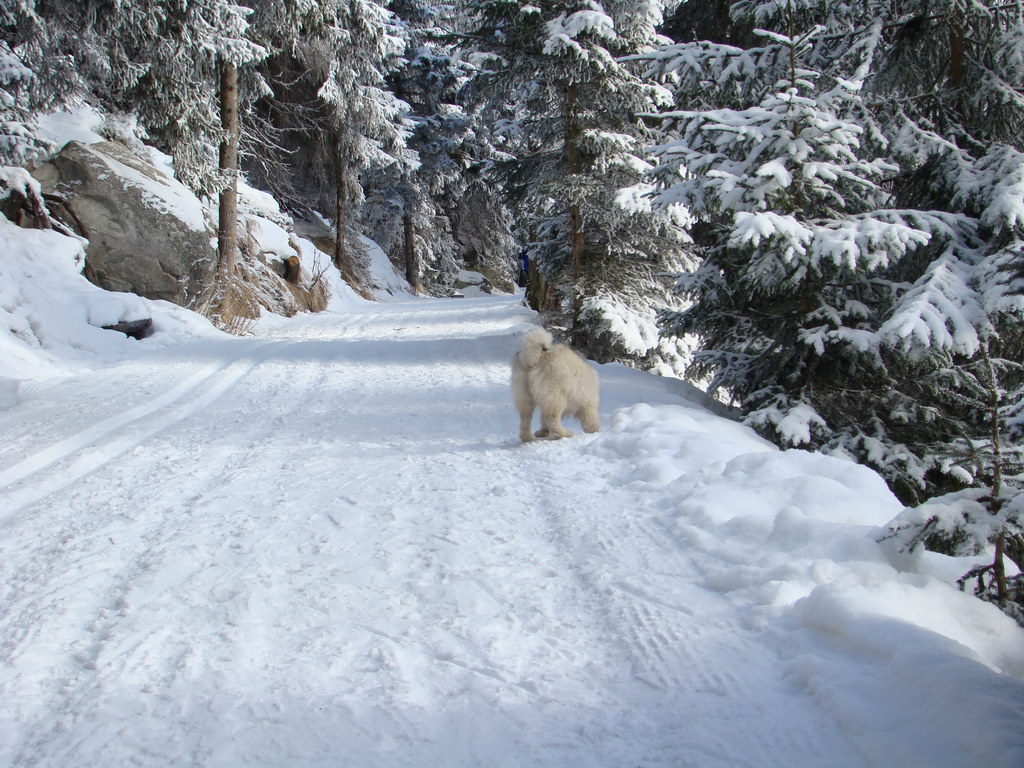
[217, 60, 240, 285]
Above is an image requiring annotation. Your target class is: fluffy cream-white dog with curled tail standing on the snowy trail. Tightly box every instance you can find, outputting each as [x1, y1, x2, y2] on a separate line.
[512, 328, 601, 442]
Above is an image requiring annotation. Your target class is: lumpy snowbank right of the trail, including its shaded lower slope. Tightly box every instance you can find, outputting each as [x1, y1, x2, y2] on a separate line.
[589, 404, 1024, 766]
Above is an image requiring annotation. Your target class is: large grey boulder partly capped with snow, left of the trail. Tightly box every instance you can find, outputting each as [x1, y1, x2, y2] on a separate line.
[33, 141, 217, 307]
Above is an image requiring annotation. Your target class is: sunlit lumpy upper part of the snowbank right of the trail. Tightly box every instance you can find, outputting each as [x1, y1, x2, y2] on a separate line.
[589, 403, 1024, 663]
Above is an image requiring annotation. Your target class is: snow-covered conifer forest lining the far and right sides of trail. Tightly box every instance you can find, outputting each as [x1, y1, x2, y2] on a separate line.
[0, 0, 1024, 621]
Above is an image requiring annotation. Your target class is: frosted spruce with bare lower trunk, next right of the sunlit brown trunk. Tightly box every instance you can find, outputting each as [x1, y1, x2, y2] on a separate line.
[247, 0, 415, 282]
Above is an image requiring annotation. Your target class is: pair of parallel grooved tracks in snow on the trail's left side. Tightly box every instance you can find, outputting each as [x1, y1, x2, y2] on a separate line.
[0, 342, 296, 524]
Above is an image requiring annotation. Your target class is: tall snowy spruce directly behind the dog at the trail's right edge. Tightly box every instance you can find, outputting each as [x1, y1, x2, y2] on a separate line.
[460, 0, 685, 366]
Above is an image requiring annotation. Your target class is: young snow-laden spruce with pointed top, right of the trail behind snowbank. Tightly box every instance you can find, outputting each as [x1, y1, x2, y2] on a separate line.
[654, 16, 930, 444]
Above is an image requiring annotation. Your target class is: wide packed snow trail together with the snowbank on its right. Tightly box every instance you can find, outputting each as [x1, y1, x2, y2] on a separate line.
[0, 297, 1024, 768]
